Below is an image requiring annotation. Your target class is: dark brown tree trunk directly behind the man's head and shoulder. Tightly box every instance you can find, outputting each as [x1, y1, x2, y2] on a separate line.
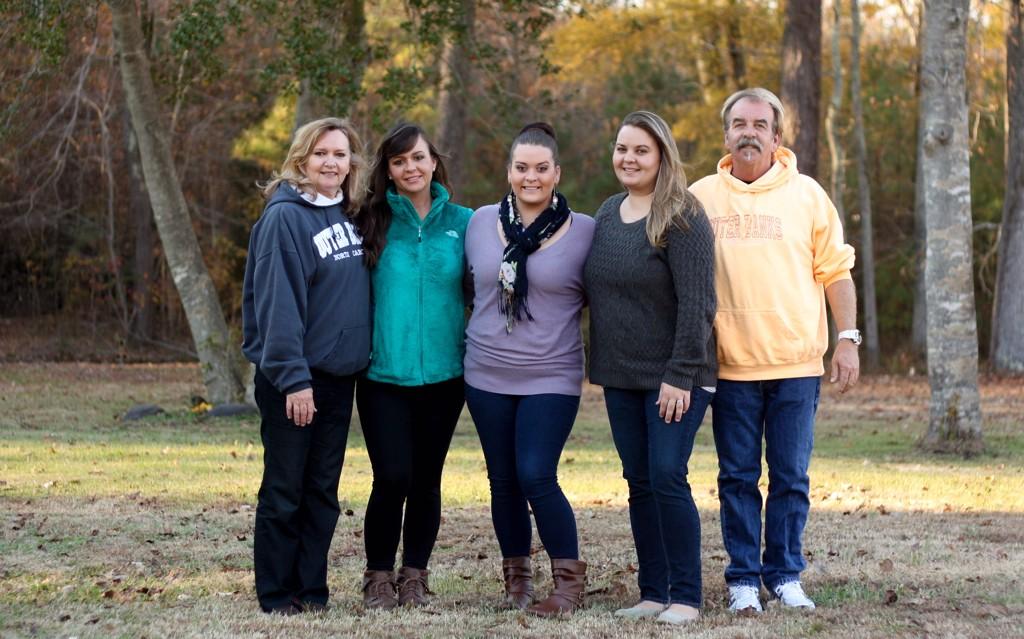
[779, 0, 821, 178]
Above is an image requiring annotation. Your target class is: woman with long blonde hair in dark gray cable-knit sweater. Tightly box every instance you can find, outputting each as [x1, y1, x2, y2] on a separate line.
[584, 111, 718, 625]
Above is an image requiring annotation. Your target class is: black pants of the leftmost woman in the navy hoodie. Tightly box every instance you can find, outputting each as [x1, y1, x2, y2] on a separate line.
[253, 368, 355, 610]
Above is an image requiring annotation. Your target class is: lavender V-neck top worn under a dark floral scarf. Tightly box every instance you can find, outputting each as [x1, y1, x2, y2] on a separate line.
[465, 204, 594, 395]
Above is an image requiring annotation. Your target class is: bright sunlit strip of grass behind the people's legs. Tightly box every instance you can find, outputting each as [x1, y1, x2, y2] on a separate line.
[0, 401, 1024, 512]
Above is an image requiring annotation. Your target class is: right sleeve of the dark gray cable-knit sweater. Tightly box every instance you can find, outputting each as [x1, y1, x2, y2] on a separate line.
[662, 201, 717, 390]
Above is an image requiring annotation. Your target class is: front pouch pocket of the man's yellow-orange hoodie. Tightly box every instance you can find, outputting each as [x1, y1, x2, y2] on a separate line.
[715, 309, 814, 367]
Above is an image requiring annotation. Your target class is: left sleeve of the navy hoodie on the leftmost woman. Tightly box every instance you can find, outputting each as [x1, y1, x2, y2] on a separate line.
[253, 217, 312, 394]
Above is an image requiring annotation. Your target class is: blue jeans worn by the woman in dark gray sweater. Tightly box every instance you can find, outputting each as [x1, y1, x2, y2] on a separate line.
[604, 388, 712, 608]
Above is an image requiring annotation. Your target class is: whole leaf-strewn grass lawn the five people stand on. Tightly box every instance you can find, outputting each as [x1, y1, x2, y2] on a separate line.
[0, 364, 1024, 639]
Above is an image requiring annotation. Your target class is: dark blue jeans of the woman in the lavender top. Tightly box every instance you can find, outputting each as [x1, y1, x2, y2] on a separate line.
[466, 384, 580, 559]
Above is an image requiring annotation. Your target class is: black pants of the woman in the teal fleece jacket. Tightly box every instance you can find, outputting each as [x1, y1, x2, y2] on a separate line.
[355, 377, 464, 570]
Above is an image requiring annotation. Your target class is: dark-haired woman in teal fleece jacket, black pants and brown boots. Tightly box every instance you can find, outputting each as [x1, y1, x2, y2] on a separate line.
[356, 124, 472, 608]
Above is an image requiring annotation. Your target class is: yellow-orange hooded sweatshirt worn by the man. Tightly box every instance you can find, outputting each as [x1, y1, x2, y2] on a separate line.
[690, 146, 854, 381]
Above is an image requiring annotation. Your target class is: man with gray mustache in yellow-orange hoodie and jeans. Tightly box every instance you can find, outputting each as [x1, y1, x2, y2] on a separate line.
[691, 88, 860, 612]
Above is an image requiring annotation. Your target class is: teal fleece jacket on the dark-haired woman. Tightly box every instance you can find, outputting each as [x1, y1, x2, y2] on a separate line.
[367, 182, 473, 386]
